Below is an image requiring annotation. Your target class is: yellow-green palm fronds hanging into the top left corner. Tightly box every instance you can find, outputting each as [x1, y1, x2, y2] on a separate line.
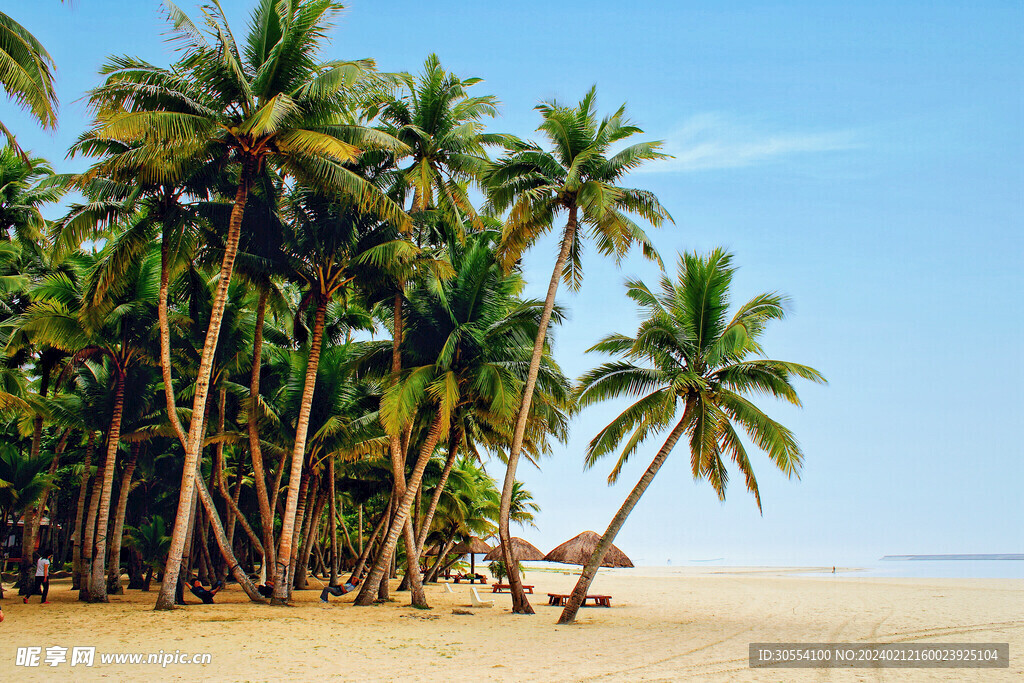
[0, 12, 57, 148]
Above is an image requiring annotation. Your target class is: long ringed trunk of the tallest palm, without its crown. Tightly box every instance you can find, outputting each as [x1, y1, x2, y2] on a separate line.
[155, 159, 256, 609]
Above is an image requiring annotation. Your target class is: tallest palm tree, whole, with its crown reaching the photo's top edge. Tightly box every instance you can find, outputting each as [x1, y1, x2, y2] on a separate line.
[79, 0, 403, 609]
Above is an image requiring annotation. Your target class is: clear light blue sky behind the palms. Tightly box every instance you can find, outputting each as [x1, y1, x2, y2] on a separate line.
[0, 0, 1024, 565]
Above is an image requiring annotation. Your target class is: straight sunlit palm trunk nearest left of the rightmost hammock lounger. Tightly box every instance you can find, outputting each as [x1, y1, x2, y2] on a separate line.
[273, 297, 328, 603]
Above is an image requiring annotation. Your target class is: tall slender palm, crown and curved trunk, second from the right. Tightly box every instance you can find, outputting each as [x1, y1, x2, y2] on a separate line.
[488, 88, 671, 614]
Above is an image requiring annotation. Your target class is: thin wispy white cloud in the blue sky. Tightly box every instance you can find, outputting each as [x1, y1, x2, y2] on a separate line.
[638, 114, 856, 173]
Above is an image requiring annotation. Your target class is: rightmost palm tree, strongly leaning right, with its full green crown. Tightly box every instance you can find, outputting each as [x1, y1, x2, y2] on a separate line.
[558, 249, 824, 624]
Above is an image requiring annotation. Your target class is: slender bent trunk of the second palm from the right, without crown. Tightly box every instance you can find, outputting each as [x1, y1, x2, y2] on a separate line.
[498, 207, 577, 614]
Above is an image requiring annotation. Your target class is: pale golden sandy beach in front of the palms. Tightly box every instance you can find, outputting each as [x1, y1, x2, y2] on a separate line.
[0, 567, 1024, 681]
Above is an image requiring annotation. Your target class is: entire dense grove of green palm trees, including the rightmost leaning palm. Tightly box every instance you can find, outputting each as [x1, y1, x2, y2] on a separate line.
[0, 0, 822, 634]
